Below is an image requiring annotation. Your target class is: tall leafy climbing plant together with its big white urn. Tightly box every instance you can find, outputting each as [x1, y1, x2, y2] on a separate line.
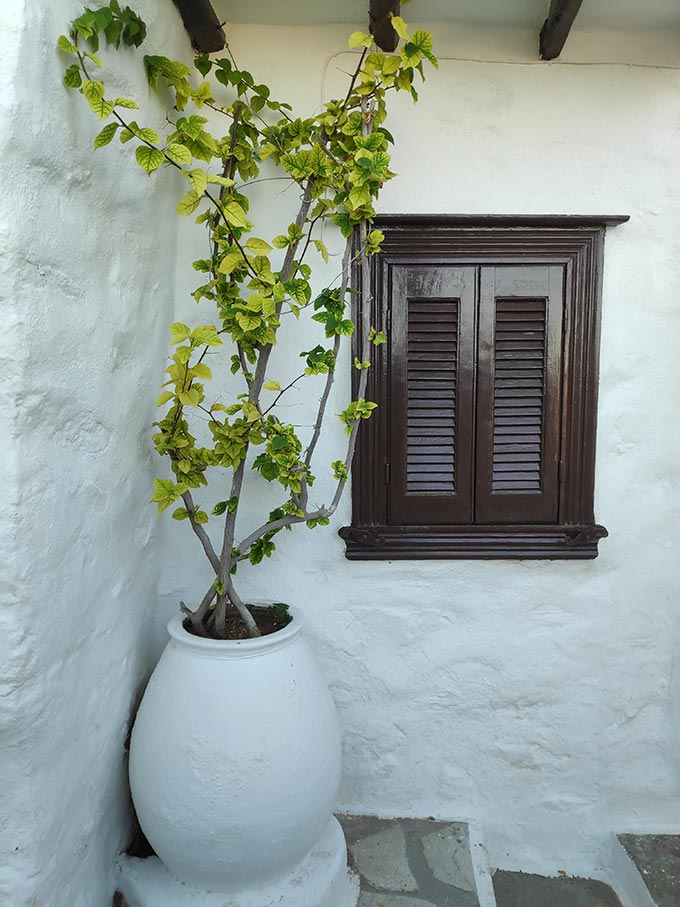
[58, 0, 436, 907]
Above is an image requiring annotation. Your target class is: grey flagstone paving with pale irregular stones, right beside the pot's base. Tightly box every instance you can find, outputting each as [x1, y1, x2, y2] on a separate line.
[339, 816, 494, 907]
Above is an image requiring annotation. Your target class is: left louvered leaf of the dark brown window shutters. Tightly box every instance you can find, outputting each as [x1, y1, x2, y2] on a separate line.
[388, 265, 476, 525]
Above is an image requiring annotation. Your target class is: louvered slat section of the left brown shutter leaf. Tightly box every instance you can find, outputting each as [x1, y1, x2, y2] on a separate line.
[406, 298, 458, 494]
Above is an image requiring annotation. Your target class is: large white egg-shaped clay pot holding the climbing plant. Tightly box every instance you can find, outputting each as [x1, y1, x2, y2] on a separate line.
[130, 609, 344, 904]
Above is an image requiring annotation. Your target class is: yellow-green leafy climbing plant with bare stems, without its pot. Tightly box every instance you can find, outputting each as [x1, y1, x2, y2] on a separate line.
[57, 0, 436, 632]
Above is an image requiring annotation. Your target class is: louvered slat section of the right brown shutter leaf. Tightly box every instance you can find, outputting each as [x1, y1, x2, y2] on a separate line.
[491, 299, 546, 493]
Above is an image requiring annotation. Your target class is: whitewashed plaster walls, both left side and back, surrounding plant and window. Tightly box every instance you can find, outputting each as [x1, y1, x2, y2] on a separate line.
[0, 0, 680, 907]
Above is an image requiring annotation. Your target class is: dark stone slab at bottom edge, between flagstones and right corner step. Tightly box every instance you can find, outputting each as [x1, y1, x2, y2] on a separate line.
[493, 870, 621, 907]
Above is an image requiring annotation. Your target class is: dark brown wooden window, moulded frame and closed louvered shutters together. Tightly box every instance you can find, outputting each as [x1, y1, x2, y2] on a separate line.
[340, 214, 627, 560]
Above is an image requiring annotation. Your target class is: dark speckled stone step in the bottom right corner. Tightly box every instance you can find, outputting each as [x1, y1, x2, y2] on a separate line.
[616, 834, 680, 907]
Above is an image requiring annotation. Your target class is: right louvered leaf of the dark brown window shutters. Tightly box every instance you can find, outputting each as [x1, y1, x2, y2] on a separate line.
[475, 266, 564, 523]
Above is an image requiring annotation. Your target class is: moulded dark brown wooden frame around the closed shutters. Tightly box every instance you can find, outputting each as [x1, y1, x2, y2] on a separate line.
[339, 215, 629, 560]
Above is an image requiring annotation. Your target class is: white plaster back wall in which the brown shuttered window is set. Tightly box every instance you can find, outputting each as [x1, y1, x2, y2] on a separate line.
[157, 19, 680, 871]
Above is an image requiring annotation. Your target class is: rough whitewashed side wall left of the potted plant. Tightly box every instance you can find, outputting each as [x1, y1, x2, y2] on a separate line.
[0, 0, 189, 907]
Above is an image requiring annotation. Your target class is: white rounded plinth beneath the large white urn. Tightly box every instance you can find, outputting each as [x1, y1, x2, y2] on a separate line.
[118, 818, 359, 907]
